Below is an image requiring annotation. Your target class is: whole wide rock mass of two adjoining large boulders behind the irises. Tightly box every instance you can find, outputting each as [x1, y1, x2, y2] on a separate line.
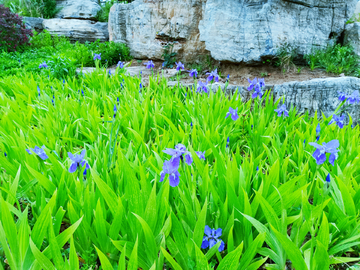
[109, 0, 357, 64]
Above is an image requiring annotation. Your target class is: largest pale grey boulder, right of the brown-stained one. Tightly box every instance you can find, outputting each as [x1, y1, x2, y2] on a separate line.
[199, 0, 357, 63]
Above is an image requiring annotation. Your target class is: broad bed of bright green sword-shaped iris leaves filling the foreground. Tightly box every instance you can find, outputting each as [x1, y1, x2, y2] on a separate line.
[0, 69, 360, 270]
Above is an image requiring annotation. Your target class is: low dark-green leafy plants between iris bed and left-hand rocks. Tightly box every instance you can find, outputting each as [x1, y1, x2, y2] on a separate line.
[0, 31, 131, 79]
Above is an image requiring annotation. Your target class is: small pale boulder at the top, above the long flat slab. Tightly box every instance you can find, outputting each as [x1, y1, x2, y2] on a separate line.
[56, 0, 101, 20]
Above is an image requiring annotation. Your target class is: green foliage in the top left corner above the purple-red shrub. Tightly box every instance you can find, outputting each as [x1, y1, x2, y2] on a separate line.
[3, 0, 60, 19]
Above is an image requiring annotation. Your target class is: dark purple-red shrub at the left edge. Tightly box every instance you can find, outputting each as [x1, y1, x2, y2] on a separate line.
[0, 5, 33, 51]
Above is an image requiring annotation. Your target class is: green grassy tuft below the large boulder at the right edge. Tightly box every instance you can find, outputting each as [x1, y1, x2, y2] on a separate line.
[305, 44, 360, 75]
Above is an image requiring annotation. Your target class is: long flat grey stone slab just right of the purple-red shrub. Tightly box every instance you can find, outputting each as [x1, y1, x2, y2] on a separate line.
[43, 19, 109, 42]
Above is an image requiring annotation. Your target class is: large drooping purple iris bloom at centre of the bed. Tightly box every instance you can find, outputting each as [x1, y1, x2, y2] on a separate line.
[160, 144, 205, 187]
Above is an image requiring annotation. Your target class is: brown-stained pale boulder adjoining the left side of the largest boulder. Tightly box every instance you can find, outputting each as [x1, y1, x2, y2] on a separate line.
[109, 0, 206, 60]
